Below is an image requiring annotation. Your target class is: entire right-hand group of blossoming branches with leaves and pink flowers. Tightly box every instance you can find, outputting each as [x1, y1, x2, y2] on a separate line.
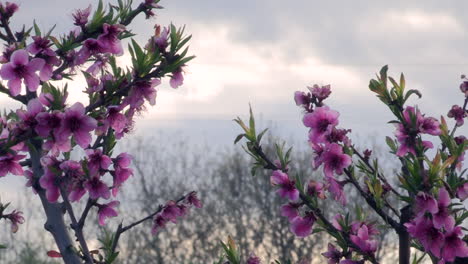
[239, 70, 468, 264]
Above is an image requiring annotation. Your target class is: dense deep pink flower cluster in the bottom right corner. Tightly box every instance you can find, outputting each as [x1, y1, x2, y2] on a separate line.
[405, 188, 468, 263]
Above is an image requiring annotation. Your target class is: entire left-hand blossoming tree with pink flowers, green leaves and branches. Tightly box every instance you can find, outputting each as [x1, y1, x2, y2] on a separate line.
[0, 0, 201, 263]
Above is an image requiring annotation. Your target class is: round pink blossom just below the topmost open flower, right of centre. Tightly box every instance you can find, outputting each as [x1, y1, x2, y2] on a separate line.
[322, 143, 352, 177]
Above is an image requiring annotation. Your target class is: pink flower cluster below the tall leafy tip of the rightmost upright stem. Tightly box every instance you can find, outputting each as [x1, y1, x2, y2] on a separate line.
[395, 106, 441, 157]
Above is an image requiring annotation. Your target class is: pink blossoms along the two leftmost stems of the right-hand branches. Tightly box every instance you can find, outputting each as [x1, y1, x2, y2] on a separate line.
[270, 85, 378, 263]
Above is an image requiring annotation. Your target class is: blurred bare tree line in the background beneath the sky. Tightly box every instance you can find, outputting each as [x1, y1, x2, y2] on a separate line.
[0, 134, 402, 264]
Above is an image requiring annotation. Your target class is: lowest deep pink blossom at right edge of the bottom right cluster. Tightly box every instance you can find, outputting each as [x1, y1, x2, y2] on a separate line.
[442, 226, 468, 262]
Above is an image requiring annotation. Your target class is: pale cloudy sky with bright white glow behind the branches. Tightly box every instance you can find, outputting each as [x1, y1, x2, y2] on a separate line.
[0, 0, 468, 196]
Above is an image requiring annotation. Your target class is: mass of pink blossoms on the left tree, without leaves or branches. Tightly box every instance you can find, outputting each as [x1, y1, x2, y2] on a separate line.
[0, 1, 193, 229]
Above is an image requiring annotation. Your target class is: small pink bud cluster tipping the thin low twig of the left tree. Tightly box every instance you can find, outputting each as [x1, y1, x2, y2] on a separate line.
[151, 192, 202, 234]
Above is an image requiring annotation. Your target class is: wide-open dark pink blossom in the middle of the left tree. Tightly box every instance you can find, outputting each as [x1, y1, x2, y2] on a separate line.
[59, 103, 97, 148]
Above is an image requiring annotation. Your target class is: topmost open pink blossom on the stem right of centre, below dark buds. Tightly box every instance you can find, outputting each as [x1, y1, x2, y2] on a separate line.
[303, 106, 340, 143]
